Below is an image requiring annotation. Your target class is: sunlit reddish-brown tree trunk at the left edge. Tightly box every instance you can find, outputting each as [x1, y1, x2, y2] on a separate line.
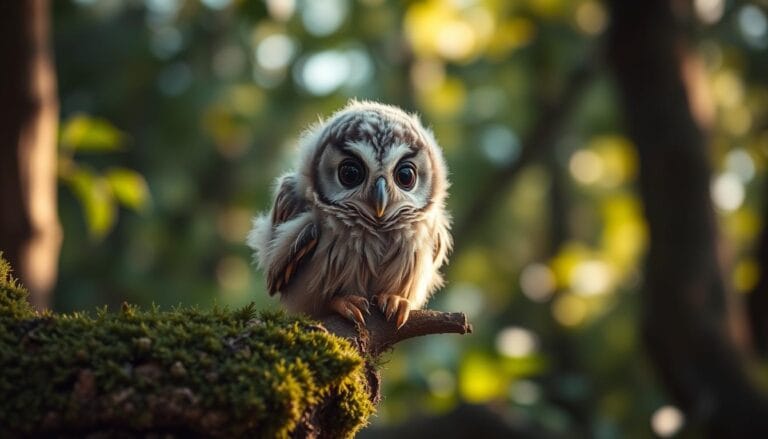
[0, 0, 61, 309]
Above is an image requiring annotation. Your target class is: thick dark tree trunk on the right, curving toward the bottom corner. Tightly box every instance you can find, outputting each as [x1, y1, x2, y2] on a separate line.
[608, 0, 768, 437]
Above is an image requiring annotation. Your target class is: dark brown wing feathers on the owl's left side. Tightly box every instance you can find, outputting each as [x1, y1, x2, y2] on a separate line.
[267, 174, 318, 295]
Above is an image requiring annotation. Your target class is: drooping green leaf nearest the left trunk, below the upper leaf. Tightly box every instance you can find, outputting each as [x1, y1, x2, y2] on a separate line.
[69, 168, 116, 240]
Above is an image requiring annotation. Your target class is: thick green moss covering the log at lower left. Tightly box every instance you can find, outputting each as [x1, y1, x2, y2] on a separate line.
[0, 259, 373, 437]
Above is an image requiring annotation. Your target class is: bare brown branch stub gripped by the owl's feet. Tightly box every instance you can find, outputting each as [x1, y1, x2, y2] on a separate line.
[322, 310, 472, 357]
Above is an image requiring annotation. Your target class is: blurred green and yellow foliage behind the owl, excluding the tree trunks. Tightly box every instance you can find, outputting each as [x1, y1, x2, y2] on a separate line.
[54, 0, 768, 438]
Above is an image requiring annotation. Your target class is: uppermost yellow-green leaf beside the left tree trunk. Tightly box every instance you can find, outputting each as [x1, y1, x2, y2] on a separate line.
[61, 114, 125, 152]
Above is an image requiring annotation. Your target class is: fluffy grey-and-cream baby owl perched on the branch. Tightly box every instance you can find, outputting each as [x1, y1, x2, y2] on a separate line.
[248, 101, 452, 329]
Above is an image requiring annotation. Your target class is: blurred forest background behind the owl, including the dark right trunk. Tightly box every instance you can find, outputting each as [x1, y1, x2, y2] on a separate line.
[0, 0, 768, 438]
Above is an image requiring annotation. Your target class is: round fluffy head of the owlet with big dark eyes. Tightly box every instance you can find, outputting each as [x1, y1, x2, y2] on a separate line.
[302, 101, 448, 224]
